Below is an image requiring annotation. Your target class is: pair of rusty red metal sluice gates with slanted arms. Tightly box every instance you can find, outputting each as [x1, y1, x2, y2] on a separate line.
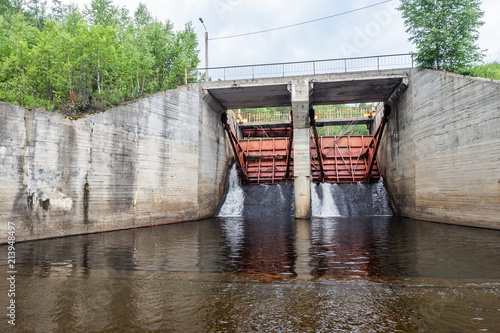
[222, 107, 387, 184]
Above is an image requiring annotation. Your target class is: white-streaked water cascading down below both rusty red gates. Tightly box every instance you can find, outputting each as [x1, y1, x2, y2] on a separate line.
[217, 165, 392, 220]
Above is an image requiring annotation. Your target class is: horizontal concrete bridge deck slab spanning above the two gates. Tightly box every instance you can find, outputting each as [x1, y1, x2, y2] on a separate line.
[202, 69, 409, 109]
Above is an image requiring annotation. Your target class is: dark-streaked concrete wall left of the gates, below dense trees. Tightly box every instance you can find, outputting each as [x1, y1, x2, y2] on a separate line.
[0, 85, 232, 242]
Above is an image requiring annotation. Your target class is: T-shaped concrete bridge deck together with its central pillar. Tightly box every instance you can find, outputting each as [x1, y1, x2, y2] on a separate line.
[209, 70, 408, 218]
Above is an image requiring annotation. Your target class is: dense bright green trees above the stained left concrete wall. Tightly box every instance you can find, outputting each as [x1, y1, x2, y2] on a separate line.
[0, 0, 199, 114]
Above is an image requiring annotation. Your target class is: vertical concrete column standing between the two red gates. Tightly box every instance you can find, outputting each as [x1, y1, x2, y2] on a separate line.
[291, 78, 311, 219]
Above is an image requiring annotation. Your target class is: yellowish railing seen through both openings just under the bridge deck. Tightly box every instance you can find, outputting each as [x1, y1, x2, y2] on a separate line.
[228, 106, 376, 123]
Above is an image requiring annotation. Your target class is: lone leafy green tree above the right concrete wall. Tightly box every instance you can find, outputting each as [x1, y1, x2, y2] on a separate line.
[399, 0, 484, 71]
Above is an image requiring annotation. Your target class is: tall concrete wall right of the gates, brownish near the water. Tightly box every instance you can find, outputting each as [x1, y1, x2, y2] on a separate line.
[379, 70, 500, 228]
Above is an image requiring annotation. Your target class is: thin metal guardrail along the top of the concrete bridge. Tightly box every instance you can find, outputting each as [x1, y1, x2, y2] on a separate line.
[185, 53, 413, 82]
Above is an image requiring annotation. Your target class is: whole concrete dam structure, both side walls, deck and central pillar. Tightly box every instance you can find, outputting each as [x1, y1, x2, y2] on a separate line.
[0, 54, 500, 242]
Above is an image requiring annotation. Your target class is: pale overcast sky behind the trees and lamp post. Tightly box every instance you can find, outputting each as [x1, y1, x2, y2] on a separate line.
[62, 0, 500, 67]
